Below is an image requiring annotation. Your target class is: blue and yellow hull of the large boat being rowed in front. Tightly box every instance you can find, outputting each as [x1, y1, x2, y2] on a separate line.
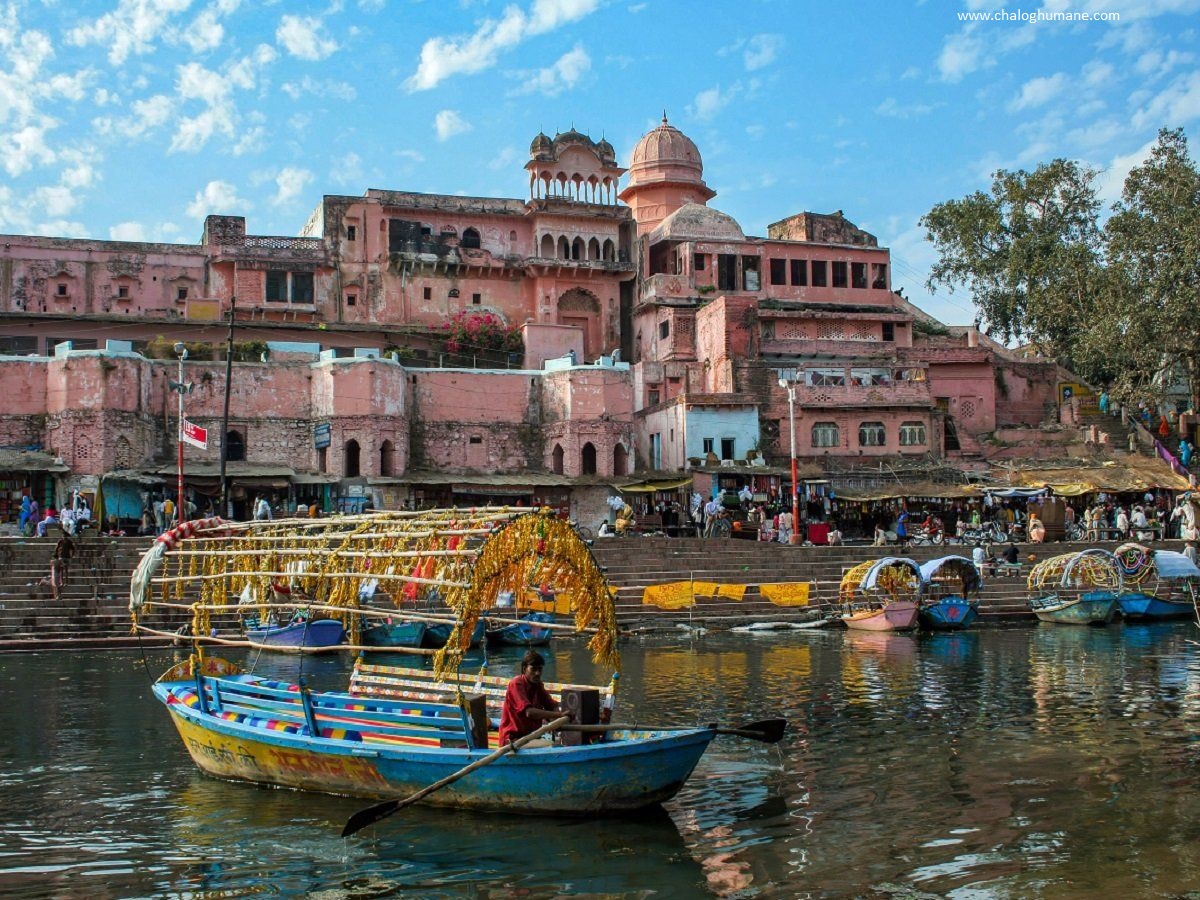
[154, 664, 716, 815]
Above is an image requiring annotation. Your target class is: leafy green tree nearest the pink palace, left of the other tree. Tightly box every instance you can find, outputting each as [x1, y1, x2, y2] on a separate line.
[920, 160, 1103, 365]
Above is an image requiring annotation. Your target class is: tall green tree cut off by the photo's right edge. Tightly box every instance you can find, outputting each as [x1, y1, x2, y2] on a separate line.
[1087, 128, 1200, 407]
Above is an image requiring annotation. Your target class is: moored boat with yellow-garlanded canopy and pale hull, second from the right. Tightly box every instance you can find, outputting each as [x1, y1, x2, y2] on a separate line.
[1027, 548, 1121, 625]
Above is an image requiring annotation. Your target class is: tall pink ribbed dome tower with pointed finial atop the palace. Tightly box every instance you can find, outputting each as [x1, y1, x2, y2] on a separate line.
[620, 113, 716, 235]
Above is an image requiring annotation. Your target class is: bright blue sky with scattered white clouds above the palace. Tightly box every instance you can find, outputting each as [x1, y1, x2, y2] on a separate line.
[0, 0, 1200, 324]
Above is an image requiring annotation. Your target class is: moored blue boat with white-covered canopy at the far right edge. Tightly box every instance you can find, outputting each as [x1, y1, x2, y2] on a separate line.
[1114, 544, 1200, 622]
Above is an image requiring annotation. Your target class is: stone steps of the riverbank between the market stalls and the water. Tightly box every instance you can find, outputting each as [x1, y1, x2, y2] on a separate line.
[0, 536, 1166, 650]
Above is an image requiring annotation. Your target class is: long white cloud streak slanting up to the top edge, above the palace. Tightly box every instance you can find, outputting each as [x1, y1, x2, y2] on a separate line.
[404, 0, 600, 91]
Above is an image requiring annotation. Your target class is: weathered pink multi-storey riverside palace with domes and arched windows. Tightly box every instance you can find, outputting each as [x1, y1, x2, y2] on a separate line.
[0, 118, 1069, 521]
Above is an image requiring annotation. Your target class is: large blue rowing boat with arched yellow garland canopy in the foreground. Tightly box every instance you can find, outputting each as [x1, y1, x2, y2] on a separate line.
[131, 508, 785, 814]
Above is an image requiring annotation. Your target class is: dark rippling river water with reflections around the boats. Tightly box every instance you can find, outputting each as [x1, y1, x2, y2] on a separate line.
[0, 623, 1200, 899]
